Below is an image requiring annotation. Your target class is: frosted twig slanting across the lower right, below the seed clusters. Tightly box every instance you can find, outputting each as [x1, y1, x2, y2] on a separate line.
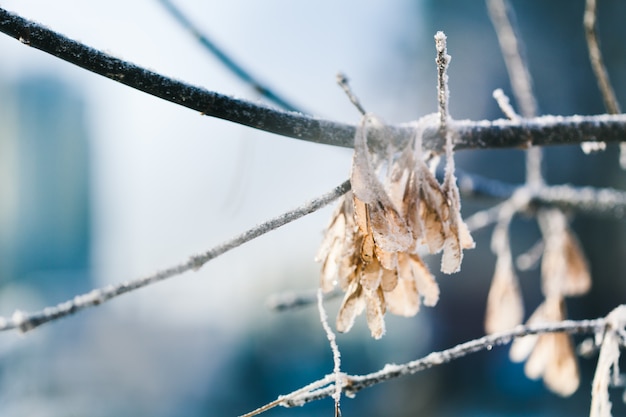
[245, 318, 606, 407]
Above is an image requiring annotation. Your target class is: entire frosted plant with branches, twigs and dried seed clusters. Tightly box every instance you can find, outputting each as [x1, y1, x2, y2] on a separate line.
[0, 0, 626, 417]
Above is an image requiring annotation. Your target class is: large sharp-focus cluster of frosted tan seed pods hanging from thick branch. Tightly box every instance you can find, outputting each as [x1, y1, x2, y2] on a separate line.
[317, 114, 474, 339]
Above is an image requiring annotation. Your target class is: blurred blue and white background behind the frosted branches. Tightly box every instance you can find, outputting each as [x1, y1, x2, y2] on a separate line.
[0, 0, 626, 417]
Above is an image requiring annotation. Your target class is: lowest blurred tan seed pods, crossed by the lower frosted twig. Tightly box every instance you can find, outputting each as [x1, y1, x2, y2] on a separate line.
[510, 297, 580, 397]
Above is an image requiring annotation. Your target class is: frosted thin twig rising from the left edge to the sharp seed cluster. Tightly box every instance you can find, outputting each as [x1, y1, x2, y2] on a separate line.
[0, 181, 350, 332]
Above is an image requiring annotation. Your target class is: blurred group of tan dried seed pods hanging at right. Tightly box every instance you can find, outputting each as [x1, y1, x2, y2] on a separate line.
[485, 209, 591, 396]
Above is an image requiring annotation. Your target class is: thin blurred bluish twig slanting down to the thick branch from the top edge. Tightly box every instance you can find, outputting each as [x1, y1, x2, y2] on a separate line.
[158, 0, 304, 113]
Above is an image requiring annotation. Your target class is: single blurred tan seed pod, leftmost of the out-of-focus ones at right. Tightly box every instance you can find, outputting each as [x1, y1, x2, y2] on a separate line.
[485, 254, 524, 334]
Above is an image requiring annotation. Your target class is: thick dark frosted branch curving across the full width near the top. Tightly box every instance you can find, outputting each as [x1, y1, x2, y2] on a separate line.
[0, 8, 626, 151]
